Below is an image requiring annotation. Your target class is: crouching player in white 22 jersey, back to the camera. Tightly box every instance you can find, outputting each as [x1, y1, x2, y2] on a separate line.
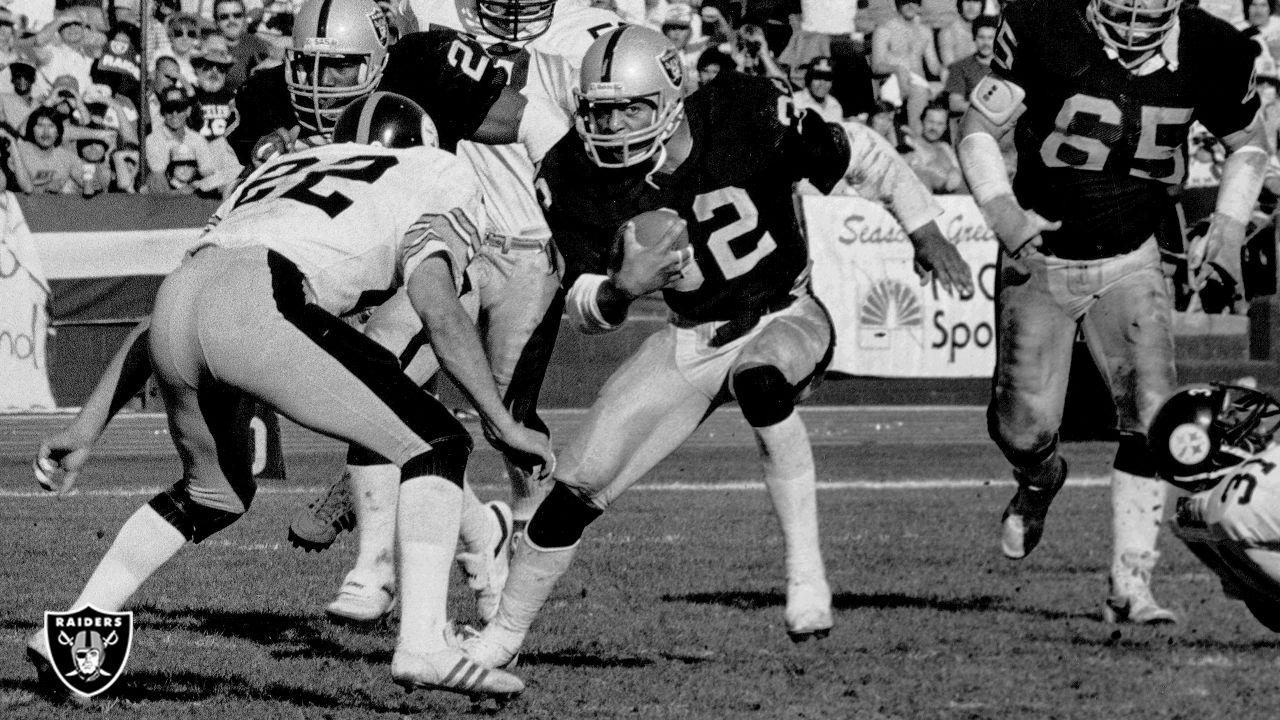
[28, 92, 554, 697]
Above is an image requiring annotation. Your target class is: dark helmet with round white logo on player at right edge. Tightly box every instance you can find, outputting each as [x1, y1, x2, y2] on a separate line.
[1147, 383, 1280, 492]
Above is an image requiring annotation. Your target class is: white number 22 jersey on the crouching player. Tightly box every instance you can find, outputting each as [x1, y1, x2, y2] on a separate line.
[202, 142, 483, 315]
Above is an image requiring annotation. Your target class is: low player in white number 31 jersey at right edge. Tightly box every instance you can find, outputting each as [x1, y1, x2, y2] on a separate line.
[1148, 383, 1280, 632]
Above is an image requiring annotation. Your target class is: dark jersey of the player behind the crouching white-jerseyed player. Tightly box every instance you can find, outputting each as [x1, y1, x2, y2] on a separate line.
[228, 26, 507, 167]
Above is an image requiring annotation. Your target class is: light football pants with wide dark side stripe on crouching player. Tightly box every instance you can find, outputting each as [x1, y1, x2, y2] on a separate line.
[151, 247, 470, 512]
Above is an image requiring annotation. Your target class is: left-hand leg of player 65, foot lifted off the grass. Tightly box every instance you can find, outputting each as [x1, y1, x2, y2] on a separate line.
[987, 254, 1075, 560]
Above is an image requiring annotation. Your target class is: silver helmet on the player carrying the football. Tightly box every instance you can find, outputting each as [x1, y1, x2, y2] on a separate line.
[573, 26, 685, 168]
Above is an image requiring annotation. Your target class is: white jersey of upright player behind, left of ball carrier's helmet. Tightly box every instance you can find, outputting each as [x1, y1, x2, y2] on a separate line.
[410, 0, 622, 241]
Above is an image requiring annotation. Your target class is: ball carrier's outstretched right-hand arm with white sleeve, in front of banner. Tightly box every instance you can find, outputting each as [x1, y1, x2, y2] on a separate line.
[833, 123, 973, 296]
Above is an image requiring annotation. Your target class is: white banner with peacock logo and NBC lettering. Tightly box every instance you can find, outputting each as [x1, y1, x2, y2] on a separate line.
[803, 196, 998, 378]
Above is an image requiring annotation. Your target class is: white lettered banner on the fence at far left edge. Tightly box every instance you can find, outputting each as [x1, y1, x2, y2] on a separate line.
[0, 192, 55, 413]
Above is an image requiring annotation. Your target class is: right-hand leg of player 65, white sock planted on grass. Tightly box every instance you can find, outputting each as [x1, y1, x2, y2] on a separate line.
[1083, 241, 1176, 624]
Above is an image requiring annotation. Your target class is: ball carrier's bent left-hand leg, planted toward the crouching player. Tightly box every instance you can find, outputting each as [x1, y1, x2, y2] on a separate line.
[463, 327, 716, 667]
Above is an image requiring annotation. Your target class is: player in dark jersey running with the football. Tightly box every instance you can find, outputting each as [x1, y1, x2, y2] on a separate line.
[463, 26, 972, 667]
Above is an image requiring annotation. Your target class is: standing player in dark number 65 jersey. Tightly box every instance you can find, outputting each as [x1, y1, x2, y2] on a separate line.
[959, 0, 1268, 623]
